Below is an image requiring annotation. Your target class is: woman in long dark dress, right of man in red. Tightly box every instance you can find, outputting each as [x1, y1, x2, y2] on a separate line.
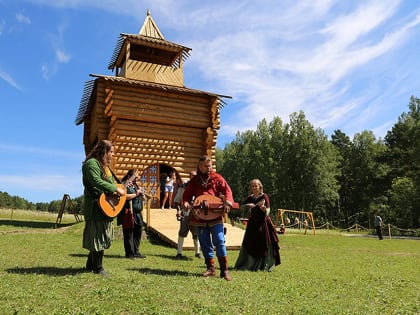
[235, 179, 280, 271]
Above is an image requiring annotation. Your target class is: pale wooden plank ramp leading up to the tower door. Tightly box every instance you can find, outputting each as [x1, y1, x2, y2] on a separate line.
[143, 208, 245, 250]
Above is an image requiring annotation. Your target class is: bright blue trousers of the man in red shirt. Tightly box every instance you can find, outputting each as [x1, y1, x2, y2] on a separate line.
[197, 223, 226, 258]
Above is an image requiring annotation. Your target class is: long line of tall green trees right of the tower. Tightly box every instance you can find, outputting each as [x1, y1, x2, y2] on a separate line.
[216, 97, 420, 228]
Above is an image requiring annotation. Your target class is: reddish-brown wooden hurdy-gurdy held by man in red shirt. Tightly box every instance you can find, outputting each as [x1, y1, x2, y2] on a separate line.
[191, 195, 239, 221]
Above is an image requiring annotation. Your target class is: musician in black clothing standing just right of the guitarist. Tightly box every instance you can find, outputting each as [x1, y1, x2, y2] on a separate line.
[117, 169, 146, 259]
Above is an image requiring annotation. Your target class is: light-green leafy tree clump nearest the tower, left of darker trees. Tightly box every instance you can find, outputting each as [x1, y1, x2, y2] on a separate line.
[219, 112, 339, 225]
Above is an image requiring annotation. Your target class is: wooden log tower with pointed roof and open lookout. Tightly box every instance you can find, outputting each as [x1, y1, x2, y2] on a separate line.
[75, 11, 230, 208]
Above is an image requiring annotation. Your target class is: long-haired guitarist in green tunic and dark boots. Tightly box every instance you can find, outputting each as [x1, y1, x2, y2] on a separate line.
[82, 140, 125, 277]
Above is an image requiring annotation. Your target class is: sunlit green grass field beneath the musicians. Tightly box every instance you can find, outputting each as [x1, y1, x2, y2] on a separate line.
[0, 210, 420, 315]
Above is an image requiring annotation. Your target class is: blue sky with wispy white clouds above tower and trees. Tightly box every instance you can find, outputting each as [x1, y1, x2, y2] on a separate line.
[0, 0, 420, 202]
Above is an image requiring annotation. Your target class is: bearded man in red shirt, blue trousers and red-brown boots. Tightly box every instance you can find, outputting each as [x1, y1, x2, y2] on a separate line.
[182, 156, 234, 281]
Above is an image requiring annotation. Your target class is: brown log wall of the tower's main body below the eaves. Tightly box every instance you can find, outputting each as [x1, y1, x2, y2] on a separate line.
[84, 78, 220, 189]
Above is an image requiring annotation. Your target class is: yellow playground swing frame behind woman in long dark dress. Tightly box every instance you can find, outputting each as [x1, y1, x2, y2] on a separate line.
[276, 209, 315, 235]
